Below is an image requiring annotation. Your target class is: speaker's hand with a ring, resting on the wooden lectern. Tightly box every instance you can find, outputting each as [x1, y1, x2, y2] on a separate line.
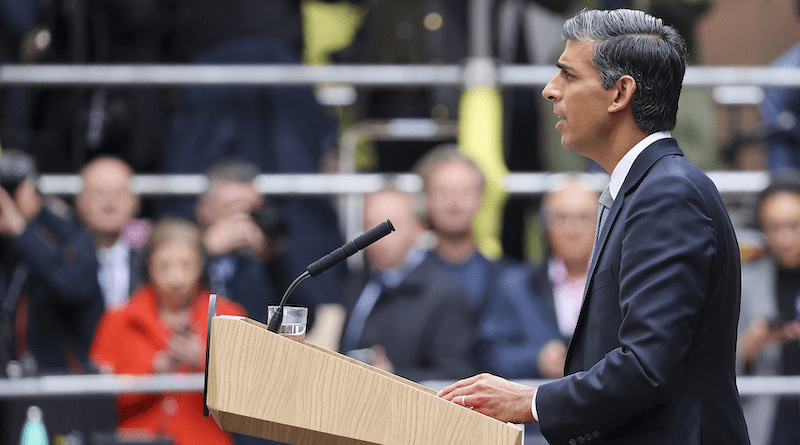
[438, 374, 536, 423]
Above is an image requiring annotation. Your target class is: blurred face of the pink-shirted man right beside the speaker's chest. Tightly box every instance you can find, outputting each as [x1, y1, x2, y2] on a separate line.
[546, 185, 599, 264]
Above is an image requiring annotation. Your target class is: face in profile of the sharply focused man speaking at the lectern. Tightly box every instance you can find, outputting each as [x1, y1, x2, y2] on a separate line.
[542, 40, 615, 159]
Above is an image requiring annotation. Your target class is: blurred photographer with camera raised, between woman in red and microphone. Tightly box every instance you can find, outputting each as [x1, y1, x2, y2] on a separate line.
[196, 160, 284, 322]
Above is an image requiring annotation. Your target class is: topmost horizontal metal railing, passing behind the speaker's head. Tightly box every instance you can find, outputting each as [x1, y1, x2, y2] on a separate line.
[0, 64, 800, 87]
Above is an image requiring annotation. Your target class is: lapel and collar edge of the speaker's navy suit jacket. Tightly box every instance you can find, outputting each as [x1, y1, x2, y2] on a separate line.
[565, 138, 683, 372]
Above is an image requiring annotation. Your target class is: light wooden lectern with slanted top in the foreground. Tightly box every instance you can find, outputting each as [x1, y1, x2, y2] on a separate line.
[205, 316, 522, 445]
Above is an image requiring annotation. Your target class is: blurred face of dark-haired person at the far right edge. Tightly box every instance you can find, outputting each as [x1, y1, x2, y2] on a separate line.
[759, 192, 800, 269]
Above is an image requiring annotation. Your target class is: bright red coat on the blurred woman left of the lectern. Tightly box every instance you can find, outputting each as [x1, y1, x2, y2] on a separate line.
[90, 285, 245, 445]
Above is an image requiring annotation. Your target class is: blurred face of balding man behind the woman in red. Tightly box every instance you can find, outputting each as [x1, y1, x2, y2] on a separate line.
[77, 161, 139, 234]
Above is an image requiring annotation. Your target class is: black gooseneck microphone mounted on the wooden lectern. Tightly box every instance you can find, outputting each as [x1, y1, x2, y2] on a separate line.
[267, 219, 394, 333]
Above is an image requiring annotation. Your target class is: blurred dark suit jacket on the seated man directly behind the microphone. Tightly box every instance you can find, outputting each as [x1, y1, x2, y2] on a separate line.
[342, 253, 475, 381]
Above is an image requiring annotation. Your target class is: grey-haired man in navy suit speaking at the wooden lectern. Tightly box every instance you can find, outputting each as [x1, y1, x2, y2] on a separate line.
[440, 10, 749, 445]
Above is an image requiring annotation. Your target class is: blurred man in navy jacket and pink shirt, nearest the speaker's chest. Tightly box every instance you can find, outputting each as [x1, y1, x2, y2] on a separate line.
[477, 179, 600, 378]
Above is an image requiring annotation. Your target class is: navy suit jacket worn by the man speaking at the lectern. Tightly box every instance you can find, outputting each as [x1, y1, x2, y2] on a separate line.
[536, 139, 749, 445]
